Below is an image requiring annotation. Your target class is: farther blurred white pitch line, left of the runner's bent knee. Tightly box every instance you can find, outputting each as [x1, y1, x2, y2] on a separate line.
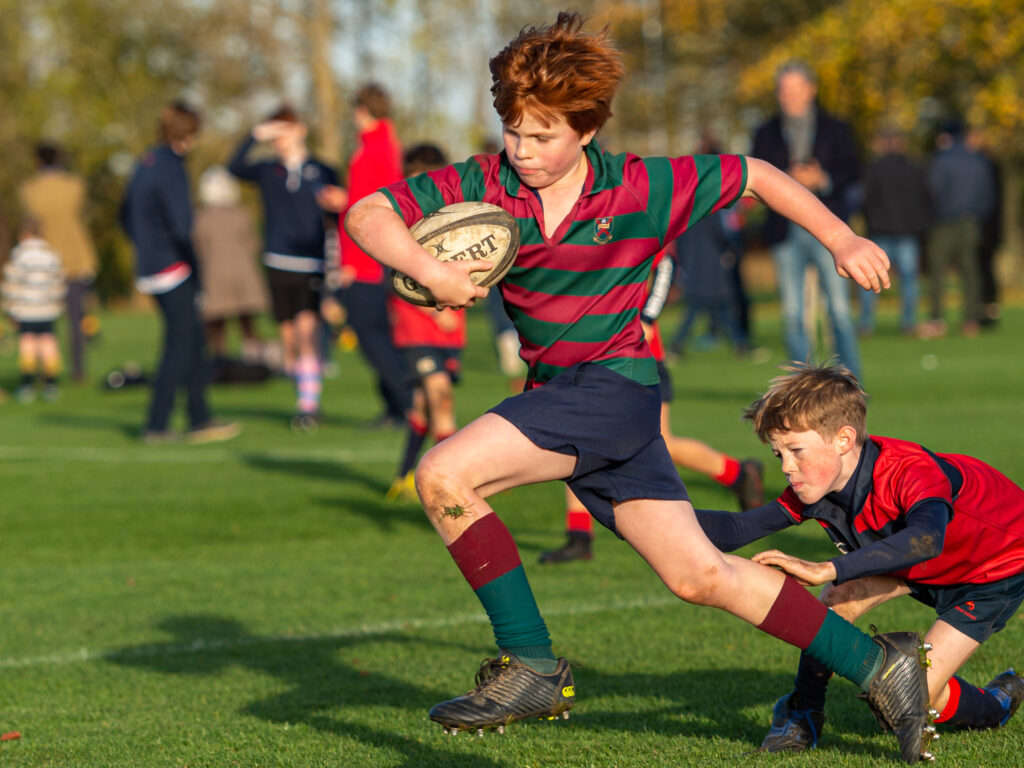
[0, 445, 397, 464]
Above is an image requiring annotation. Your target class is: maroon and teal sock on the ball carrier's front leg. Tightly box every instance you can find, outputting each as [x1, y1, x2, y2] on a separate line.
[447, 514, 556, 674]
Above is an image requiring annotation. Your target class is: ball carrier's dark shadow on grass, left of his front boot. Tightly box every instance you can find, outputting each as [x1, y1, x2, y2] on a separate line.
[106, 615, 503, 768]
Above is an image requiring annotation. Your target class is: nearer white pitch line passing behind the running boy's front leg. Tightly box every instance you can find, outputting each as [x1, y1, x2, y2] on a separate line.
[0, 595, 680, 669]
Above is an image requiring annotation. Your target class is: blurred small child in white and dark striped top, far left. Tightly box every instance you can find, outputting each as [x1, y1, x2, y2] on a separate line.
[2, 218, 66, 402]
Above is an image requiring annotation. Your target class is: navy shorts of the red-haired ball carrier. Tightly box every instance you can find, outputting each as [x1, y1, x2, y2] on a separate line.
[489, 362, 689, 536]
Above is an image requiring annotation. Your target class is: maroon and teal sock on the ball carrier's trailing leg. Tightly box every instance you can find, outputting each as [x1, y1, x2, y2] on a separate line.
[758, 577, 883, 690]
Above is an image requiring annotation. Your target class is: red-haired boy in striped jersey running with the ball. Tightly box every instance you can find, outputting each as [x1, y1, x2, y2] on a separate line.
[346, 12, 933, 762]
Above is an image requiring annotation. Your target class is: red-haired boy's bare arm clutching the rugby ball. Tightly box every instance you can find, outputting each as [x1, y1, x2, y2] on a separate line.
[345, 193, 490, 308]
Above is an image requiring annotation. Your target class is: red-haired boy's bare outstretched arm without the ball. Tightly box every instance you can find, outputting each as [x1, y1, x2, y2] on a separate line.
[743, 158, 891, 293]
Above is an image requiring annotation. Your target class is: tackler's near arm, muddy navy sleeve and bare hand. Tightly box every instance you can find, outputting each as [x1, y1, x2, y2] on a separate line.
[753, 499, 951, 586]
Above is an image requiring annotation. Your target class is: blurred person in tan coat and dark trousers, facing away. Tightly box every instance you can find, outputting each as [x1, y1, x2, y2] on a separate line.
[18, 142, 96, 381]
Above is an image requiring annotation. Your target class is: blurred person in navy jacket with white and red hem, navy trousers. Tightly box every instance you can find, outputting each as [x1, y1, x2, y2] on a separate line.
[121, 101, 241, 444]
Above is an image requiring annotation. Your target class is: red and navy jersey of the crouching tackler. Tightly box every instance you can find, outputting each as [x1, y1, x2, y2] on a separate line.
[776, 435, 1024, 586]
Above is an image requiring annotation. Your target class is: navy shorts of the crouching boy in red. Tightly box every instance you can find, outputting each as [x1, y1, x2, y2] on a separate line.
[906, 573, 1024, 643]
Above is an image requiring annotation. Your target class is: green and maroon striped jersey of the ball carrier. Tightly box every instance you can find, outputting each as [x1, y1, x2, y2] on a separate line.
[381, 141, 746, 384]
